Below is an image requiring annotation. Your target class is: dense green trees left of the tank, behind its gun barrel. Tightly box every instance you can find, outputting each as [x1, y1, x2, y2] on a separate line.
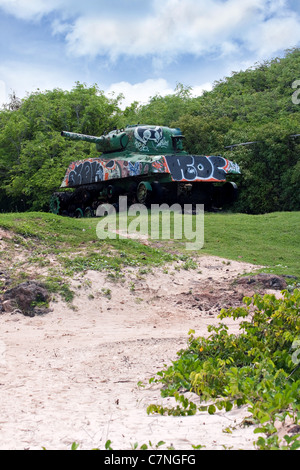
[0, 83, 119, 211]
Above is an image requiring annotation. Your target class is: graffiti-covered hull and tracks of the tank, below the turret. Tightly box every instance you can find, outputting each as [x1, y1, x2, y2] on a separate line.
[50, 153, 239, 217]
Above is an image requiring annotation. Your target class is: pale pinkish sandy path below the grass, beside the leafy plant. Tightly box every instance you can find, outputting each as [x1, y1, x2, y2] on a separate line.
[0, 256, 270, 450]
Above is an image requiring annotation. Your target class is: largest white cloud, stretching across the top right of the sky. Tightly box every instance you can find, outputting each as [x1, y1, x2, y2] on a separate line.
[61, 0, 300, 61]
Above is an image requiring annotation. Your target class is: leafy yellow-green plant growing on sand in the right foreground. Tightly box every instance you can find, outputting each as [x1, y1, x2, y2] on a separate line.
[147, 289, 300, 449]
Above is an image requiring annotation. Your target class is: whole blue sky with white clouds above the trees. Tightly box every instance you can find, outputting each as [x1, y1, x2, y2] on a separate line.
[0, 0, 300, 107]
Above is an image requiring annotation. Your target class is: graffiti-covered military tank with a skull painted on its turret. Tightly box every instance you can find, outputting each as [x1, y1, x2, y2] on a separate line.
[50, 125, 240, 217]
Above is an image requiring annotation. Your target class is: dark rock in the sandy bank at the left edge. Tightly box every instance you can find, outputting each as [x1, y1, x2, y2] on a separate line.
[2, 281, 50, 317]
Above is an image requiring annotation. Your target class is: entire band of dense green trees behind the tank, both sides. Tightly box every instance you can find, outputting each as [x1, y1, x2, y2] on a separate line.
[0, 49, 300, 214]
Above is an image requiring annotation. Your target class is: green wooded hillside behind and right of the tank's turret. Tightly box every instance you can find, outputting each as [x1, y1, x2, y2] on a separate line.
[132, 49, 300, 214]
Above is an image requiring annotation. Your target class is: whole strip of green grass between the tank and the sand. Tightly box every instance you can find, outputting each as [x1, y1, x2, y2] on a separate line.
[0, 212, 300, 278]
